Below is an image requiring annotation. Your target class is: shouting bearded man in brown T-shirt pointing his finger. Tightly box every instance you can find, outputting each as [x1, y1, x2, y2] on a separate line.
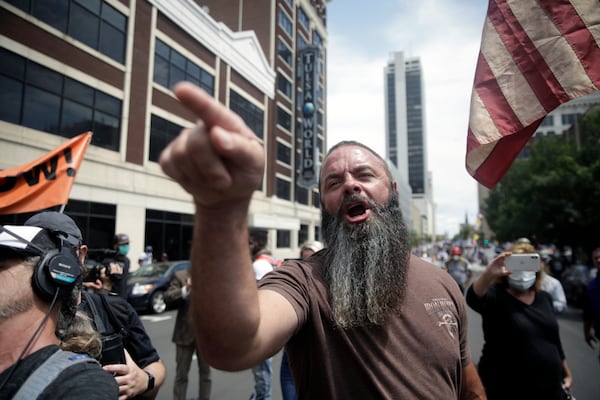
[160, 83, 485, 400]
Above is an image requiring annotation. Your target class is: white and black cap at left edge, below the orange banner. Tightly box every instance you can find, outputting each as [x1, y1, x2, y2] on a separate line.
[0, 225, 58, 256]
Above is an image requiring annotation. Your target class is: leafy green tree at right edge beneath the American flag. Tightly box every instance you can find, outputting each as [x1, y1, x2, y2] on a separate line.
[484, 109, 600, 260]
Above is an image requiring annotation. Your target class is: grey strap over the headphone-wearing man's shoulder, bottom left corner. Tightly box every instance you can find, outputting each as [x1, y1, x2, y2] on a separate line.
[13, 349, 100, 400]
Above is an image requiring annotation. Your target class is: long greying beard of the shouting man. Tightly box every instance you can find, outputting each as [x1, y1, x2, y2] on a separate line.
[322, 196, 410, 328]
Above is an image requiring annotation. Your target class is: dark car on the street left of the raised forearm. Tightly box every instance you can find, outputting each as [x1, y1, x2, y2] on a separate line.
[127, 260, 190, 314]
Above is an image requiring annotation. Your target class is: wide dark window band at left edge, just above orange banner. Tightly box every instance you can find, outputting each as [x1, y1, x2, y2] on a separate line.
[0, 49, 121, 151]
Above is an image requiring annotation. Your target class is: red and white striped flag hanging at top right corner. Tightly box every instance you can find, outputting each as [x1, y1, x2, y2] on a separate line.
[466, 0, 600, 188]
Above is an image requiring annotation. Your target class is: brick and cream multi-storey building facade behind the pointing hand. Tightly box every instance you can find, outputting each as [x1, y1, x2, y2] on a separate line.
[0, 0, 326, 265]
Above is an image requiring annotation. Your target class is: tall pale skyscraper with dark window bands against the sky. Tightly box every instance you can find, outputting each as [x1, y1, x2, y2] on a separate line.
[384, 52, 435, 235]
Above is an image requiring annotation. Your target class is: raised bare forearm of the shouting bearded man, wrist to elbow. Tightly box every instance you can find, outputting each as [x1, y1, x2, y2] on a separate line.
[191, 207, 260, 370]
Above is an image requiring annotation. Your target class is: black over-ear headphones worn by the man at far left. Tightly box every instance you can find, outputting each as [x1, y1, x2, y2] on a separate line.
[31, 238, 83, 301]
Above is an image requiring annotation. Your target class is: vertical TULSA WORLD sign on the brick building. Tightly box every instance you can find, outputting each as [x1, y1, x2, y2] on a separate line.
[298, 46, 319, 189]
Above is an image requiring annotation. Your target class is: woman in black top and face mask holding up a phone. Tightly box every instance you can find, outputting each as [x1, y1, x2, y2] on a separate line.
[466, 243, 573, 400]
